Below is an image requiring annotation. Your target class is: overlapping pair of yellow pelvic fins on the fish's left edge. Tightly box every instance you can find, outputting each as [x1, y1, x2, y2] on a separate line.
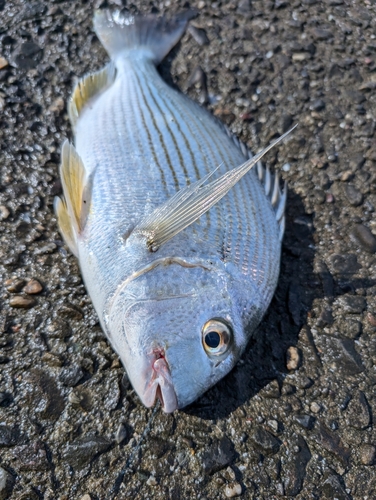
[55, 141, 91, 255]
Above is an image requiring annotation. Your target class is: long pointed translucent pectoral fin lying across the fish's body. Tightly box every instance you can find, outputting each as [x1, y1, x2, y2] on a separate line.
[134, 127, 295, 252]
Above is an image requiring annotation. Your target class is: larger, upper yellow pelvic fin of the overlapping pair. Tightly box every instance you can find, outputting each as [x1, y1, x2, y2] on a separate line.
[60, 140, 91, 237]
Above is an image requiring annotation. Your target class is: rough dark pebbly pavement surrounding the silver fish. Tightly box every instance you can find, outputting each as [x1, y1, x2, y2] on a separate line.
[0, 0, 376, 500]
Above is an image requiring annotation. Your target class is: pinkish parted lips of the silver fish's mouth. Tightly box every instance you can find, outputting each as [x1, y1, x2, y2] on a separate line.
[142, 349, 178, 413]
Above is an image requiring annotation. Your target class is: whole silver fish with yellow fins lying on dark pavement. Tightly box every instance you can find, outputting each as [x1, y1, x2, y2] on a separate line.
[55, 10, 289, 413]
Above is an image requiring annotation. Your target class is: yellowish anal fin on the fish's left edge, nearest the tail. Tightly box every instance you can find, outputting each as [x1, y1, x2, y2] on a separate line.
[68, 63, 116, 127]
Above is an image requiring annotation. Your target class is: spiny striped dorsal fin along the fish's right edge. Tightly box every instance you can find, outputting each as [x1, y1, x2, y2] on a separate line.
[223, 120, 288, 241]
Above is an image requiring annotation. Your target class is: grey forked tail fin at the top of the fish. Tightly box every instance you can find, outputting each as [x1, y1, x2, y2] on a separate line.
[94, 10, 192, 64]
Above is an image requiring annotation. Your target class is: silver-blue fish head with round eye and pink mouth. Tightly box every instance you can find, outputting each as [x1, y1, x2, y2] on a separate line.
[106, 266, 254, 413]
